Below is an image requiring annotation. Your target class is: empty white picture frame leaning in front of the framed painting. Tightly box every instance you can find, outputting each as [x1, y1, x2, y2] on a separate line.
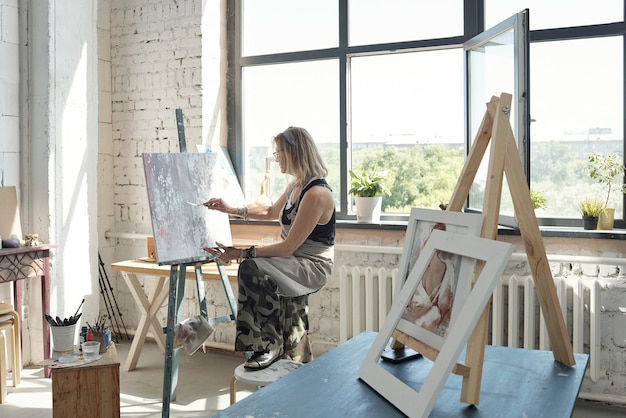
[358, 231, 513, 417]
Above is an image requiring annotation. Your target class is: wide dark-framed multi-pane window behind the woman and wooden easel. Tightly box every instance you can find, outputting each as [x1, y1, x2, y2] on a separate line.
[228, 0, 626, 226]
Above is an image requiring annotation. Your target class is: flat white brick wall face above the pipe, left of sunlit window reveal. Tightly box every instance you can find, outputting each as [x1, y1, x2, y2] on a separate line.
[110, 0, 208, 238]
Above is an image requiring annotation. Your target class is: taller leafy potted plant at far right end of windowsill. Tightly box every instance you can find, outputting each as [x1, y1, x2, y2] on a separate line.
[587, 152, 626, 229]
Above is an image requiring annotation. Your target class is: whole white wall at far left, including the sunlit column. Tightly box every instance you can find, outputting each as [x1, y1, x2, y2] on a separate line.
[0, 0, 99, 362]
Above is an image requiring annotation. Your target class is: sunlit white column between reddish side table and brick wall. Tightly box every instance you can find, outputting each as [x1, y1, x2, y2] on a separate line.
[22, 0, 99, 362]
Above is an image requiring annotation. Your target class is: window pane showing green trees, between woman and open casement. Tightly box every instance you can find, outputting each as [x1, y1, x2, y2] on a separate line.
[350, 49, 464, 213]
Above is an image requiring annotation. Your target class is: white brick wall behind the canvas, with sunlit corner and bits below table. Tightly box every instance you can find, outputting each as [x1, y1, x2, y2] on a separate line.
[98, 0, 228, 356]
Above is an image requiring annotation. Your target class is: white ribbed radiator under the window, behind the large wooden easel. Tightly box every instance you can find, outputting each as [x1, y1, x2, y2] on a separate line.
[339, 266, 601, 382]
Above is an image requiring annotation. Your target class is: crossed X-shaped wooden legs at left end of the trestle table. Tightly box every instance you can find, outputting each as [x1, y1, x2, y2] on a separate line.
[121, 272, 168, 372]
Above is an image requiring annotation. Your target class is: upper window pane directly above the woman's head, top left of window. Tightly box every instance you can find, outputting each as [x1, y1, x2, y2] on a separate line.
[241, 0, 339, 56]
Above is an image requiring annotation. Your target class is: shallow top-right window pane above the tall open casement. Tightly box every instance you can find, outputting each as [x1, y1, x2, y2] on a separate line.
[485, 0, 624, 30]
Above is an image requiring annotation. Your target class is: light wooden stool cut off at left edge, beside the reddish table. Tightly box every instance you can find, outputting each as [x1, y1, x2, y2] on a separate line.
[0, 303, 22, 403]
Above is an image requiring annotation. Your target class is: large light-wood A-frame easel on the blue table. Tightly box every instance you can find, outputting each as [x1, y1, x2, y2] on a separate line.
[393, 93, 576, 405]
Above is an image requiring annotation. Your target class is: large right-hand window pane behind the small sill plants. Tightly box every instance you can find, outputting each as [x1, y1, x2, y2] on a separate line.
[530, 37, 624, 219]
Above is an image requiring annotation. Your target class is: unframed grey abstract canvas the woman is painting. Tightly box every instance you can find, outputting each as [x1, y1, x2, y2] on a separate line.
[143, 153, 232, 265]
